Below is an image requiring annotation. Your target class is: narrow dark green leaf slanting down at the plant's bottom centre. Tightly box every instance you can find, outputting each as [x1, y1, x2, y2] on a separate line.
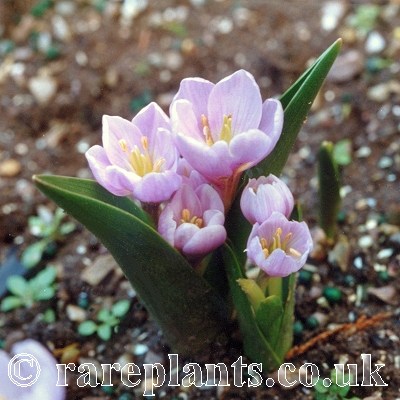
[223, 244, 283, 371]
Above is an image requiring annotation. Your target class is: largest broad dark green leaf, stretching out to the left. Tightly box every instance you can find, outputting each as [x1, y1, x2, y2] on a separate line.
[34, 176, 227, 355]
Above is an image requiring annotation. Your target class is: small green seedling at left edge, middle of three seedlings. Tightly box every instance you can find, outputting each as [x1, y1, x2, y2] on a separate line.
[0, 266, 57, 312]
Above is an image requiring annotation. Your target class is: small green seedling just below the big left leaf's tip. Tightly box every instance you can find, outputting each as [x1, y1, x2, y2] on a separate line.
[21, 206, 76, 268]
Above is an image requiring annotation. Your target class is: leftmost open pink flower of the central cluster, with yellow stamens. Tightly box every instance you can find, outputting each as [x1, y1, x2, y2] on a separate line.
[86, 103, 181, 203]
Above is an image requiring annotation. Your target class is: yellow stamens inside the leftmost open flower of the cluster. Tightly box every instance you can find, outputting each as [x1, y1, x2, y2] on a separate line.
[118, 136, 165, 176]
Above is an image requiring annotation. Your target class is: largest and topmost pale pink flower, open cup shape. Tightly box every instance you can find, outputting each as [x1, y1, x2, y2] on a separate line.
[170, 70, 283, 185]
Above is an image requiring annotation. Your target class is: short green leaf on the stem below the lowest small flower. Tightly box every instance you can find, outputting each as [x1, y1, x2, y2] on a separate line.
[256, 295, 283, 349]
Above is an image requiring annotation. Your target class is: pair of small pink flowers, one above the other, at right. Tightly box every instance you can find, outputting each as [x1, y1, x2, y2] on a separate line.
[240, 175, 312, 277]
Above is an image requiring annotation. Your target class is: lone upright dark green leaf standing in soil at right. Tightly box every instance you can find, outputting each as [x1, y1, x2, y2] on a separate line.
[318, 142, 341, 240]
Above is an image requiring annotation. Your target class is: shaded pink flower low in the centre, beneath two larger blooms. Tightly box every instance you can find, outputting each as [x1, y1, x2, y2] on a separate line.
[158, 184, 226, 260]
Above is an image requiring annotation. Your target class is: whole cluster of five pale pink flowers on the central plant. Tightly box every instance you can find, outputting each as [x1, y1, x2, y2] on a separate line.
[86, 70, 309, 275]
